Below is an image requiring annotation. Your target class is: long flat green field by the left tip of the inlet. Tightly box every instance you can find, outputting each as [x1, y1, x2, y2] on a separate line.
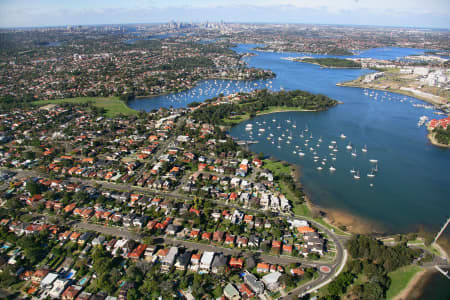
[33, 97, 138, 117]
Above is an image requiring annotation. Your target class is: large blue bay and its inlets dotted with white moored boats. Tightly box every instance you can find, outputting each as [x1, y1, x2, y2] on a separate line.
[130, 45, 450, 232]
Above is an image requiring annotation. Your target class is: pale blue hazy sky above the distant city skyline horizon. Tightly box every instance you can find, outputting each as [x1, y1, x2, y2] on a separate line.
[0, 0, 450, 29]
